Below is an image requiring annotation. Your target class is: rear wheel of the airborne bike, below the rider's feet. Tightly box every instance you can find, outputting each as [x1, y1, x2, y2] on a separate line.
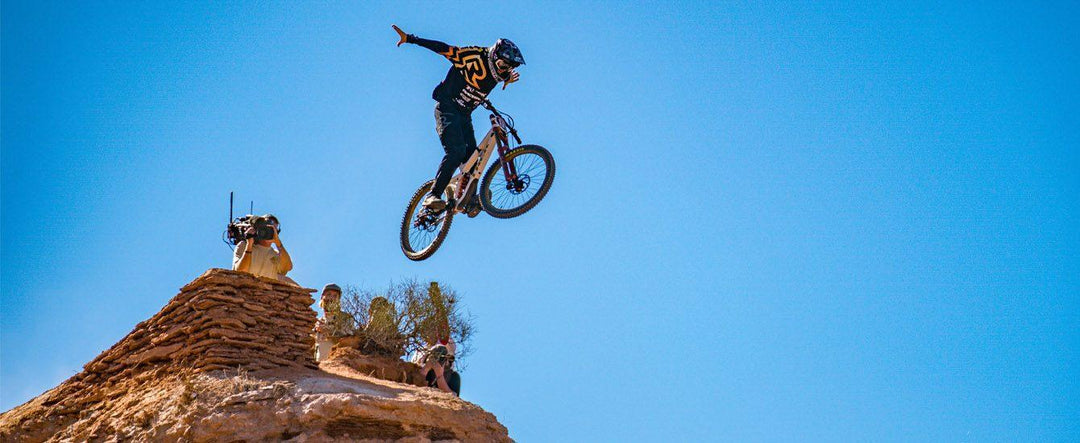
[401, 180, 454, 261]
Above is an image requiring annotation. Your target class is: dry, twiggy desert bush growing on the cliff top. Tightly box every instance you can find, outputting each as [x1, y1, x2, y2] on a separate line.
[341, 280, 475, 366]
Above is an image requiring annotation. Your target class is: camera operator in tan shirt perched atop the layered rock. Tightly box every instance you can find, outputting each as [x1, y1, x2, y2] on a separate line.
[232, 214, 296, 284]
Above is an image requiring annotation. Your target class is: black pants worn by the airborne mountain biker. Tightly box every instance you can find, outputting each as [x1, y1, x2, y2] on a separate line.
[431, 102, 476, 196]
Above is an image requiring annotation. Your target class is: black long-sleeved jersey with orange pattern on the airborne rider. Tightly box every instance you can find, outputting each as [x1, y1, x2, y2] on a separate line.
[406, 35, 502, 110]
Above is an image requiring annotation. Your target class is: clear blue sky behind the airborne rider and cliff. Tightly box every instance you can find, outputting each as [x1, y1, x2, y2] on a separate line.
[0, 1, 1080, 441]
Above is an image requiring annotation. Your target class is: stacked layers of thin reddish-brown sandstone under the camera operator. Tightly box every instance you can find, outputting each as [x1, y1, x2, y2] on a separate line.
[29, 269, 318, 412]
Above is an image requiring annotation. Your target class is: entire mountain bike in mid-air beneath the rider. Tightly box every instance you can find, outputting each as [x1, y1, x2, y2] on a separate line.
[401, 100, 555, 261]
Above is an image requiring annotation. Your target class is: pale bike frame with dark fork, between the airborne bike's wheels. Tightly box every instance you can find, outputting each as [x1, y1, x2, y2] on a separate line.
[440, 102, 522, 213]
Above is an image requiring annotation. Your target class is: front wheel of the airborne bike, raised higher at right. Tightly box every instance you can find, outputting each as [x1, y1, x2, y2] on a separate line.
[480, 145, 555, 218]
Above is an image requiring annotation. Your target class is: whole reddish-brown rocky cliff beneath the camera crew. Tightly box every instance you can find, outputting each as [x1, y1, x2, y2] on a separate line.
[0, 269, 510, 442]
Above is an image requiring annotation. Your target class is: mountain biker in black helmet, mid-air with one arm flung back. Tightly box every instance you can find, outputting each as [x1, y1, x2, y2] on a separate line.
[392, 25, 525, 211]
